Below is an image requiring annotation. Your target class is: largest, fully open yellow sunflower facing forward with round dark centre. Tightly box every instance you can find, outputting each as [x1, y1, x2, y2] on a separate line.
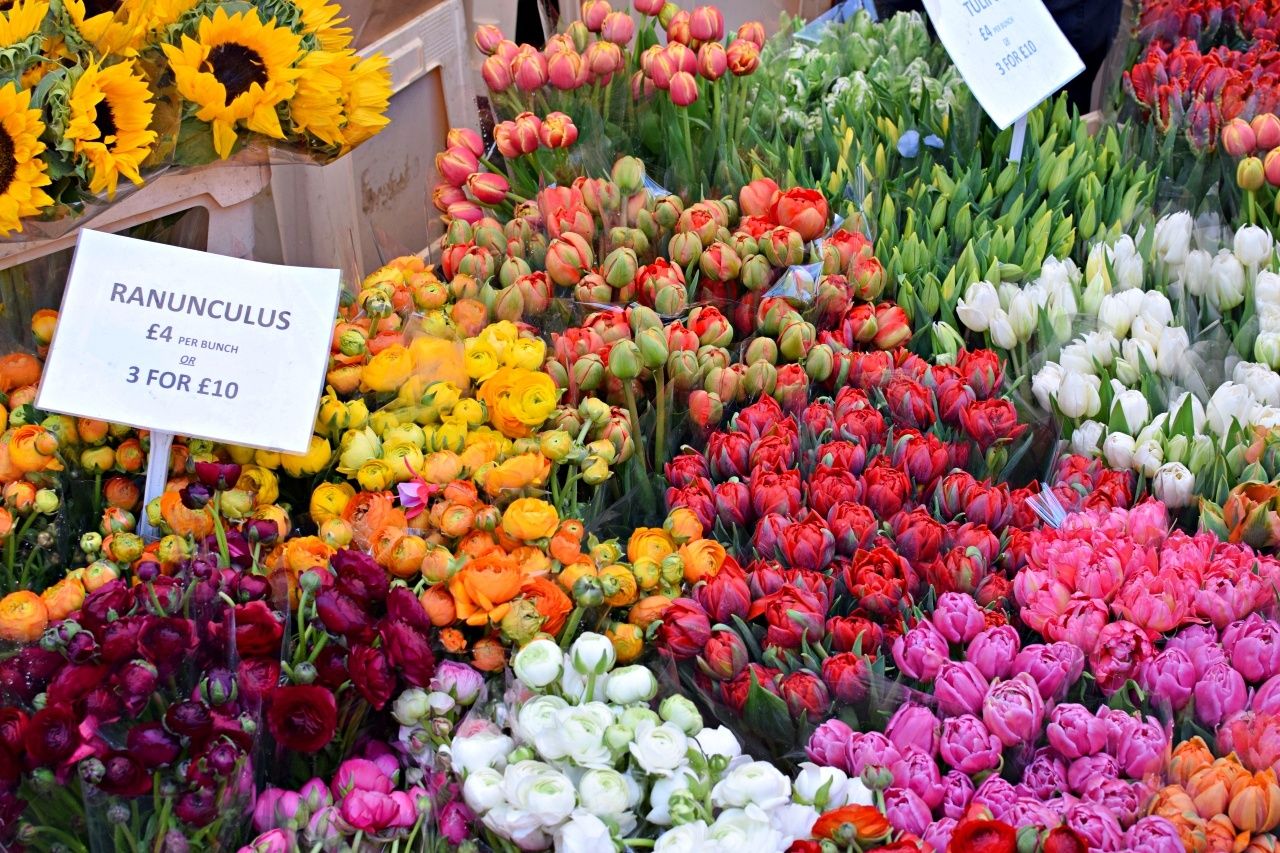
[164, 6, 302, 159]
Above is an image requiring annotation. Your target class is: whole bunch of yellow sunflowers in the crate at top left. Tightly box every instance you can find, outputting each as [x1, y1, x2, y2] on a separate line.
[0, 0, 390, 236]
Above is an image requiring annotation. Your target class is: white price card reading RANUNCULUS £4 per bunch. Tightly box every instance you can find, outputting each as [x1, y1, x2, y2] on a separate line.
[36, 225, 342, 453]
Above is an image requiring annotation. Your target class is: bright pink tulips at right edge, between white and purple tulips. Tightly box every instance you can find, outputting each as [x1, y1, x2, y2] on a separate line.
[1014, 501, 1280, 695]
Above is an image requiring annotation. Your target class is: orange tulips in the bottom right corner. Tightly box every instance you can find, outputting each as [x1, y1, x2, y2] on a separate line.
[1151, 738, 1280, 853]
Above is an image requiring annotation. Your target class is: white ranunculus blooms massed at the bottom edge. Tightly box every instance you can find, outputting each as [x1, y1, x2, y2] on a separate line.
[445, 633, 872, 853]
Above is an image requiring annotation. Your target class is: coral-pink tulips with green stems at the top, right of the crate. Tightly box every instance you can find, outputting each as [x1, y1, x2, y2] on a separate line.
[475, 0, 764, 191]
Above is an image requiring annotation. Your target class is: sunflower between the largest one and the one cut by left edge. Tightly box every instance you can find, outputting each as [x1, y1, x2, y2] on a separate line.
[67, 60, 156, 199]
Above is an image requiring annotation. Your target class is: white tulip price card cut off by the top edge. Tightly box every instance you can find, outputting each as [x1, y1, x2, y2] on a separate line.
[924, 0, 1084, 129]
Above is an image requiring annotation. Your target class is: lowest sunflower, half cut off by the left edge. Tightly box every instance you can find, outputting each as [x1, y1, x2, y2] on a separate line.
[0, 83, 54, 236]
